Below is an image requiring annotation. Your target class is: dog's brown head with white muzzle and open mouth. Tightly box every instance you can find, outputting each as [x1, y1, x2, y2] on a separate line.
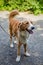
[19, 21, 35, 34]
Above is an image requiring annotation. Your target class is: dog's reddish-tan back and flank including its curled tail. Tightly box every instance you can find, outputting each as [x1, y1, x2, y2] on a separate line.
[9, 10, 19, 36]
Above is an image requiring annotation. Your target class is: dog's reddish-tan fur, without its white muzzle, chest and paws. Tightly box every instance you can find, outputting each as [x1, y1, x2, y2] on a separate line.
[9, 10, 29, 55]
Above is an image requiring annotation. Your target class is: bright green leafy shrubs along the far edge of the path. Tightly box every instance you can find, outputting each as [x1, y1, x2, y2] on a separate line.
[0, 0, 43, 14]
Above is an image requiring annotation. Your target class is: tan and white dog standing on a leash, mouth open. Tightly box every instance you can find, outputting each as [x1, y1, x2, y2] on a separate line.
[9, 10, 34, 62]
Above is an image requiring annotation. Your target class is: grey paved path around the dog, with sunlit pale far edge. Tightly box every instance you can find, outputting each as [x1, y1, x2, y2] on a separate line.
[0, 13, 43, 65]
